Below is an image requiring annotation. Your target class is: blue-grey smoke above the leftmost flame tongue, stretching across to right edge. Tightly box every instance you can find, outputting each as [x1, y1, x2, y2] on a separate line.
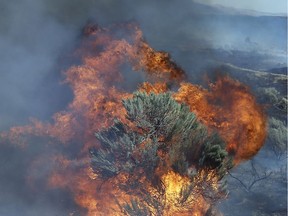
[0, 0, 286, 129]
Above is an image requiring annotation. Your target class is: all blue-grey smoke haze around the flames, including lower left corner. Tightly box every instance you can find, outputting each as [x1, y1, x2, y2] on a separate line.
[0, 0, 287, 216]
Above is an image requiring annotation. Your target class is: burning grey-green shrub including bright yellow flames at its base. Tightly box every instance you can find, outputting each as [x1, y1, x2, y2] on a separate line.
[90, 92, 232, 215]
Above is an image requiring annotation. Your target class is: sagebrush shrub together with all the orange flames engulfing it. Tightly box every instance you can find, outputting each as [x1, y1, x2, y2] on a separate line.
[0, 23, 266, 216]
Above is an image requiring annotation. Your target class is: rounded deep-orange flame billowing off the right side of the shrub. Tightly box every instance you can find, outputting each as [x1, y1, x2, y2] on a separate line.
[174, 76, 266, 163]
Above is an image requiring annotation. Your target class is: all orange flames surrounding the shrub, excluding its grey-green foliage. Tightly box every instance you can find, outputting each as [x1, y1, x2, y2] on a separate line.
[1, 23, 266, 216]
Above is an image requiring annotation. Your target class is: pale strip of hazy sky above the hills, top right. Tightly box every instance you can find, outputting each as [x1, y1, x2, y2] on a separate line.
[195, 0, 287, 14]
